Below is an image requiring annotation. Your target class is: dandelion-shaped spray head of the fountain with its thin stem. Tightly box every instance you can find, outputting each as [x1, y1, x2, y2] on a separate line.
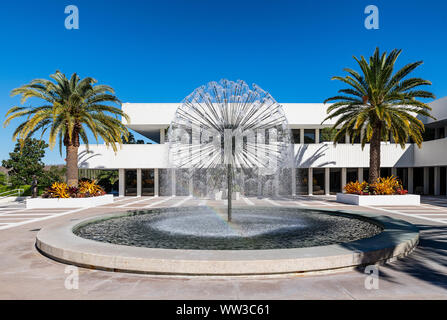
[168, 80, 293, 221]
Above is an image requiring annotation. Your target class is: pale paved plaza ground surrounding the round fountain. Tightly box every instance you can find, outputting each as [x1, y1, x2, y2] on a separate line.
[0, 196, 447, 299]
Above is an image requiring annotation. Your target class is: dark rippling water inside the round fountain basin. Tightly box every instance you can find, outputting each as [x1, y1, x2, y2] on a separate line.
[74, 207, 382, 250]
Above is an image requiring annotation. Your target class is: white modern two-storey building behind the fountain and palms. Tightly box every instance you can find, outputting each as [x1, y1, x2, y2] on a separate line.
[79, 97, 447, 196]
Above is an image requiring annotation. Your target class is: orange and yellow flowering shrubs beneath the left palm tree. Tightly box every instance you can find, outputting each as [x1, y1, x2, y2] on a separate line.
[42, 180, 105, 198]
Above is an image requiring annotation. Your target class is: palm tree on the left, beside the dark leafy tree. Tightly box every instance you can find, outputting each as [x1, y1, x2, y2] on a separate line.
[4, 71, 129, 186]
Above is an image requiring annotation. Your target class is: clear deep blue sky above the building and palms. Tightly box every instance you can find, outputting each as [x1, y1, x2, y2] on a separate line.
[0, 0, 447, 164]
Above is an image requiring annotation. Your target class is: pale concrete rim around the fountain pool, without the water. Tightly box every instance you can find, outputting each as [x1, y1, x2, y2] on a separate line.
[36, 206, 419, 276]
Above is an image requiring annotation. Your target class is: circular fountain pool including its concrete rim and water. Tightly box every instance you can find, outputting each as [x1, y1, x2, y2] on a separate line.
[36, 207, 419, 276]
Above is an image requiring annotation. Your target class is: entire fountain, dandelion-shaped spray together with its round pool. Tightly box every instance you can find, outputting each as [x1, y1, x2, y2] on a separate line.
[36, 80, 419, 275]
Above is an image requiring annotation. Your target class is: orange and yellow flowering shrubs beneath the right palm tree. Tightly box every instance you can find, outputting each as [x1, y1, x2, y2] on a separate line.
[344, 176, 408, 195]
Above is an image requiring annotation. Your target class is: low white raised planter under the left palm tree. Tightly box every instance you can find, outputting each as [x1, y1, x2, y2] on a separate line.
[26, 194, 113, 209]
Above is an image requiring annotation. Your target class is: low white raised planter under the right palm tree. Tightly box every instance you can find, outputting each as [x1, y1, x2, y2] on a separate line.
[337, 193, 421, 206]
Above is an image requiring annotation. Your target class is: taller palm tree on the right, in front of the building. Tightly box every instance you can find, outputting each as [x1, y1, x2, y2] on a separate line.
[323, 48, 435, 183]
